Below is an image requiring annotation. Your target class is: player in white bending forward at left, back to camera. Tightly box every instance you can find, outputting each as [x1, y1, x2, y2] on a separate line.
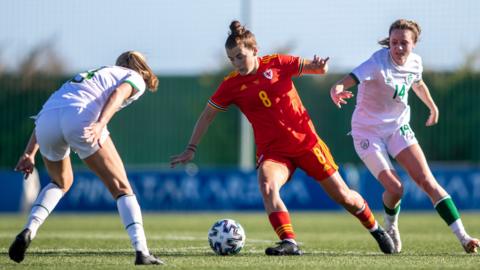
[9, 51, 163, 265]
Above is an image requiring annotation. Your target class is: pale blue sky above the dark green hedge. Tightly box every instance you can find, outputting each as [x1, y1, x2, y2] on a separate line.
[0, 0, 480, 75]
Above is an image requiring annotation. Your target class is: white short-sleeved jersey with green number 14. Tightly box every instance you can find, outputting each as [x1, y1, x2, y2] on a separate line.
[351, 48, 423, 135]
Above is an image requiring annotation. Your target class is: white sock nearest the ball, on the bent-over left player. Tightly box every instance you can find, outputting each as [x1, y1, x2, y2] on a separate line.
[117, 195, 150, 256]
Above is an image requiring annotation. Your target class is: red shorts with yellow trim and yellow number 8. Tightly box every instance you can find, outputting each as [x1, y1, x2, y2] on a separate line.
[257, 140, 338, 181]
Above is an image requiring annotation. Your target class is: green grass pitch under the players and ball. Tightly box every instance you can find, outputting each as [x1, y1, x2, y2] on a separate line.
[0, 211, 480, 270]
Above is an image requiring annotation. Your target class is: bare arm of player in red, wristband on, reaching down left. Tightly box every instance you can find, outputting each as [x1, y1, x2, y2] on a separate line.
[170, 104, 218, 168]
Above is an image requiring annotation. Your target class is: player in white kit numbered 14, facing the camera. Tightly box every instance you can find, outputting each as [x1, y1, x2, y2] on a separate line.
[330, 19, 479, 253]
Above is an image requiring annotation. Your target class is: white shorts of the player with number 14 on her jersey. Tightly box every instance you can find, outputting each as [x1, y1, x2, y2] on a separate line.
[352, 124, 418, 178]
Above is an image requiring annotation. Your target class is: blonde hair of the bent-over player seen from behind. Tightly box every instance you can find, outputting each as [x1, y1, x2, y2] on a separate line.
[115, 51, 158, 92]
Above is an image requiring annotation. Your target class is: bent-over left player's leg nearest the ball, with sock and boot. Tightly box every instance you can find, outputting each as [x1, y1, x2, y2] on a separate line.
[79, 137, 163, 264]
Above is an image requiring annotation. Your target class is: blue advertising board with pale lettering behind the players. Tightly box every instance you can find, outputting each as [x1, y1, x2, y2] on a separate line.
[0, 165, 480, 211]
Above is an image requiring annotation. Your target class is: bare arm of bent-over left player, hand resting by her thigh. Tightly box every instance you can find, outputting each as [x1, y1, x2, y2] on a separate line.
[83, 82, 136, 146]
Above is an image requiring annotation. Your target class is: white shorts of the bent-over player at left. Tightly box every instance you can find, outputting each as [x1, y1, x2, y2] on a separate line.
[35, 107, 110, 161]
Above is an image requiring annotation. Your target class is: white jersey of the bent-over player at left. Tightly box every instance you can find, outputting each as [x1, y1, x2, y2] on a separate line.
[40, 66, 146, 115]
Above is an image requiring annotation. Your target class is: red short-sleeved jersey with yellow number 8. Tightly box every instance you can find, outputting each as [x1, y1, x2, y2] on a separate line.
[208, 55, 318, 156]
